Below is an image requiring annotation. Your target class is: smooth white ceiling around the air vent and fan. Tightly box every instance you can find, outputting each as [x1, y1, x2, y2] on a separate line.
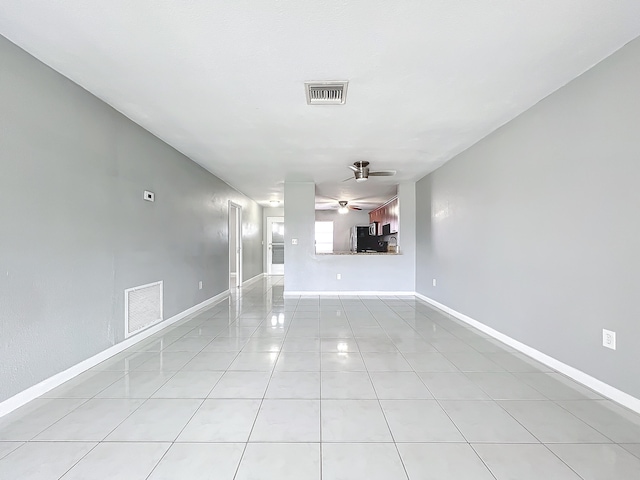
[0, 0, 640, 210]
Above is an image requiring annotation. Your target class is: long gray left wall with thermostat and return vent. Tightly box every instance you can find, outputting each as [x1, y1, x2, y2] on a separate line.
[0, 37, 263, 401]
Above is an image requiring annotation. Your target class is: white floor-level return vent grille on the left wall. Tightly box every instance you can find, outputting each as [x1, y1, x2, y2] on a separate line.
[124, 281, 162, 337]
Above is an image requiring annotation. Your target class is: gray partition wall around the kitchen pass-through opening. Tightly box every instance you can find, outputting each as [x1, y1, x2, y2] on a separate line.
[284, 182, 416, 293]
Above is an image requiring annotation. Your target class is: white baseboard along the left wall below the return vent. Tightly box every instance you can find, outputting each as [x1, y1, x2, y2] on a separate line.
[0, 290, 229, 417]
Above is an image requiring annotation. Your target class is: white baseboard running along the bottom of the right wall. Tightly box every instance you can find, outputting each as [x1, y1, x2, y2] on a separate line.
[415, 292, 640, 413]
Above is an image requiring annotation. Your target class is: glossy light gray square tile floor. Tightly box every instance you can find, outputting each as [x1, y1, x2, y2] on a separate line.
[0, 277, 640, 480]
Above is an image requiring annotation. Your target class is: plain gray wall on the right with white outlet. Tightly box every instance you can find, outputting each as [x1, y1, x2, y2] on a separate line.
[417, 36, 640, 397]
